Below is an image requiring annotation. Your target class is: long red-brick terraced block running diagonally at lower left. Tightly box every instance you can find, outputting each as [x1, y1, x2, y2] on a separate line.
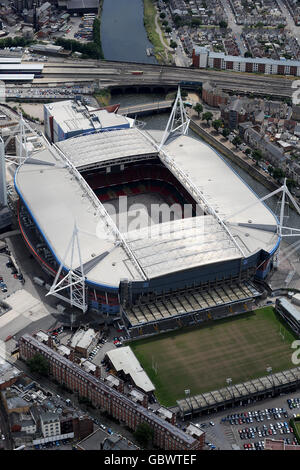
[19, 334, 205, 450]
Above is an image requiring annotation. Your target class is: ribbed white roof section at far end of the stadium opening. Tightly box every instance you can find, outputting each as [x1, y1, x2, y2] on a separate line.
[56, 127, 157, 168]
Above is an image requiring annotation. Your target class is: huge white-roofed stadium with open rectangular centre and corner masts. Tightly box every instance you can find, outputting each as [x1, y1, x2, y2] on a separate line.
[15, 93, 280, 337]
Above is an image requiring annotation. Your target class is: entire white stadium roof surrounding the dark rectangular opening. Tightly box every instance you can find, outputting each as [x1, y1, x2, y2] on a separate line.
[15, 128, 279, 290]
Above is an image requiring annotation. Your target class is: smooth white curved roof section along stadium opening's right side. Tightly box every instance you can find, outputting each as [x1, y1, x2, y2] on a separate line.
[165, 132, 279, 256]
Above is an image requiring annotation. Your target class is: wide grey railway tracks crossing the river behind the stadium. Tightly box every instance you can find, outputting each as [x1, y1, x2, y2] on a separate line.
[33, 61, 294, 97]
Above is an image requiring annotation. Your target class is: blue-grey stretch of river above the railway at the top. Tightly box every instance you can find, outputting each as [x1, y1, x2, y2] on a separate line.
[101, 0, 157, 64]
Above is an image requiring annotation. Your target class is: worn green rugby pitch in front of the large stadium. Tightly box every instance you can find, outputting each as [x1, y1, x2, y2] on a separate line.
[129, 307, 296, 406]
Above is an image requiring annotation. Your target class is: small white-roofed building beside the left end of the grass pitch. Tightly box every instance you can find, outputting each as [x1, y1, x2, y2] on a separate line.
[106, 346, 155, 393]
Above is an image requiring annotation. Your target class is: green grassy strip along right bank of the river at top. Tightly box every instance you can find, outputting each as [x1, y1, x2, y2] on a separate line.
[143, 0, 168, 64]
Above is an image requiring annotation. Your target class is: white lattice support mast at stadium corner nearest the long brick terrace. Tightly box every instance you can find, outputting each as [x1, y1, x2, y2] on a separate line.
[46, 223, 87, 313]
